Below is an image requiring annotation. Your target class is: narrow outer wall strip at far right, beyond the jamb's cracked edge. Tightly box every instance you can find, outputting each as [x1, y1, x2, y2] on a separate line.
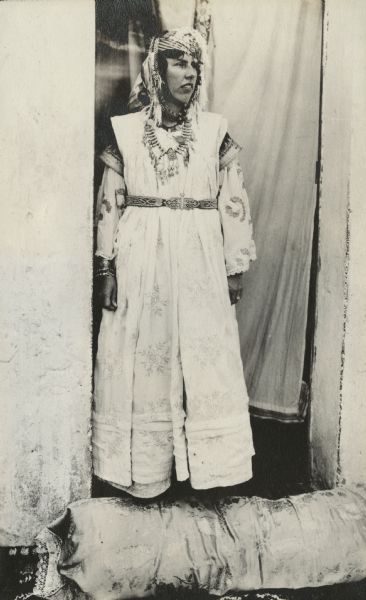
[339, 0, 366, 483]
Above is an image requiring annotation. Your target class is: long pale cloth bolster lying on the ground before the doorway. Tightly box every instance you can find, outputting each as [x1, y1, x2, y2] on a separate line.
[30, 486, 366, 600]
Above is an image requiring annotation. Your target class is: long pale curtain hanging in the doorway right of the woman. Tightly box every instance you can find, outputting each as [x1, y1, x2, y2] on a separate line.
[211, 0, 321, 421]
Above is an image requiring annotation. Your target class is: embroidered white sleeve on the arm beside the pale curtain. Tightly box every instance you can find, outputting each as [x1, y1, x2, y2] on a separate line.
[218, 160, 256, 275]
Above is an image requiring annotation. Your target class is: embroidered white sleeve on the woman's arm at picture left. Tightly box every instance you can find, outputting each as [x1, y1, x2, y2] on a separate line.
[96, 166, 126, 259]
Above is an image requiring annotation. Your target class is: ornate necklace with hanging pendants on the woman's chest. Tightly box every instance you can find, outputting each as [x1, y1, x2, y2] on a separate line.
[143, 119, 195, 184]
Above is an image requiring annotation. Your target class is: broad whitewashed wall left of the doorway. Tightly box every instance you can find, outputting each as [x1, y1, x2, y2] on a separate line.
[0, 0, 95, 544]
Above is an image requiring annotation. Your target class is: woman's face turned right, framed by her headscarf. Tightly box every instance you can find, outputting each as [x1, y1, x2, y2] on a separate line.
[165, 54, 198, 107]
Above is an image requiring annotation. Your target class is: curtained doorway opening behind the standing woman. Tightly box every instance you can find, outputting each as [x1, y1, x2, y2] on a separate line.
[94, 0, 323, 497]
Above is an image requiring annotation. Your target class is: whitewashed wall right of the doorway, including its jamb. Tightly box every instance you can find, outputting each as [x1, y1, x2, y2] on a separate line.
[310, 0, 366, 487]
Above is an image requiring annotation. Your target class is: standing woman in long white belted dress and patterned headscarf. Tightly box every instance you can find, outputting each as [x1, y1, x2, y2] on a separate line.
[93, 28, 255, 498]
